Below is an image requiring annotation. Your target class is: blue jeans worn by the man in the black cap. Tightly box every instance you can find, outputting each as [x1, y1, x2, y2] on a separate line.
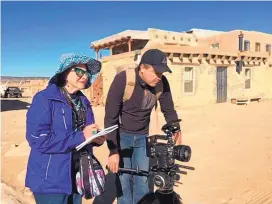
[117, 133, 149, 204]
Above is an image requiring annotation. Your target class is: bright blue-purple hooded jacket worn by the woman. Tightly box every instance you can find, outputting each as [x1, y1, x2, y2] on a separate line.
[25, 84, 94, 194]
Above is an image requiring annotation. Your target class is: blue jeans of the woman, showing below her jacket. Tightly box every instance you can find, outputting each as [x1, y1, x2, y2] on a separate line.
[33, 193, 82, 204]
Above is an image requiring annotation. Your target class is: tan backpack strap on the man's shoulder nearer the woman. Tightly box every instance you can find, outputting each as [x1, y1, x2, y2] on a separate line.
[123, 69, 136, 102]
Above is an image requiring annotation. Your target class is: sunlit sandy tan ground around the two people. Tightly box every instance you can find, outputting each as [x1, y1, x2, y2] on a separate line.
[1, 98, 272, 204]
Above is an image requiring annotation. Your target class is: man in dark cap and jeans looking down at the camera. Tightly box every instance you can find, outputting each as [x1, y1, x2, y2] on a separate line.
[104, 49, 181, 204]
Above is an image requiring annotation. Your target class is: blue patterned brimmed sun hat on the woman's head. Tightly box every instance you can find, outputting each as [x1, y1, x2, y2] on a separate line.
[49, 53, 102, 88]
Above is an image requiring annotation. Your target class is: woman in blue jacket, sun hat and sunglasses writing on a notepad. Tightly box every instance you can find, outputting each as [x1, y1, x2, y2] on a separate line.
[26, 54, 105, 204]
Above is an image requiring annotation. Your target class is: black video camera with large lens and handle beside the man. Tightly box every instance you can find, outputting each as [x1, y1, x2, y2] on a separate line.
[119, 119, 194, 194]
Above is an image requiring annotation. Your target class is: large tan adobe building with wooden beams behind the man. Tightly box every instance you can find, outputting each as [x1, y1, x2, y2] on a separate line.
[90, 28, 272, 107]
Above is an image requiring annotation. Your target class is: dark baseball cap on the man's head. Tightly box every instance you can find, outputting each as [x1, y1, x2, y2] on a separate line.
[140, 49, 172, 73]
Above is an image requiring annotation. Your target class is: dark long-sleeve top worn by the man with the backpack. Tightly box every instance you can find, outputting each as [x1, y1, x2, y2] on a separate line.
[104, 68, 178, 154]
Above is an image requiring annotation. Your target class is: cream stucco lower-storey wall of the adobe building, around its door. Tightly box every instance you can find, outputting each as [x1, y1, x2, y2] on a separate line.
[99, 55, 272, 107]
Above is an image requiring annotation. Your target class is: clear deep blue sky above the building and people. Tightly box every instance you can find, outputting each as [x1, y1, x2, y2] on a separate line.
[1, 1, 272, 77]
